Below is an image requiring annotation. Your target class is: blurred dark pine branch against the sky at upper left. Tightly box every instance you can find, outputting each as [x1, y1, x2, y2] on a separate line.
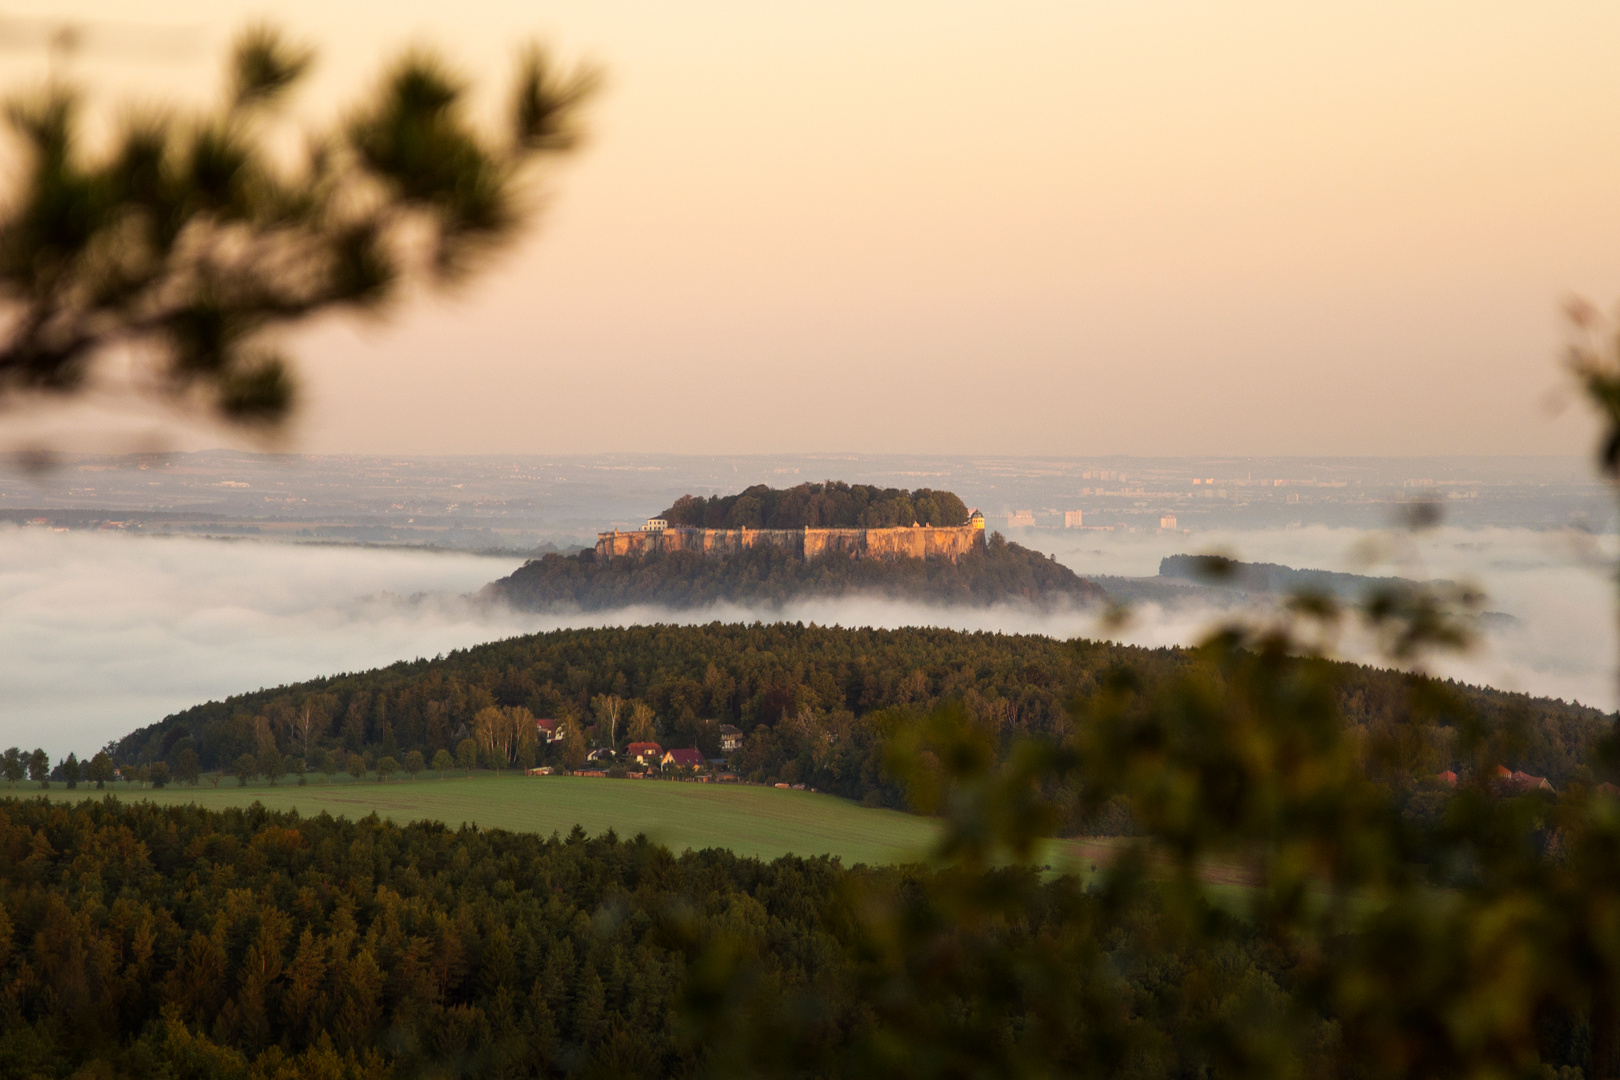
[0, 28, 595, 427]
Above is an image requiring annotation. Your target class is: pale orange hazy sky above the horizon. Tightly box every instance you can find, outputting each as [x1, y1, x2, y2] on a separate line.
[0, 0, 1620, 455]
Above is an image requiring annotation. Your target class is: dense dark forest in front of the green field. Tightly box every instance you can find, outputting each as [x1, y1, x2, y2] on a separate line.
[0, 800, 1354, 1080]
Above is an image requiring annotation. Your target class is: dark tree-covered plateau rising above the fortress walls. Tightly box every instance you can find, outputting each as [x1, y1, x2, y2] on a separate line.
[659, 481, 967, 529]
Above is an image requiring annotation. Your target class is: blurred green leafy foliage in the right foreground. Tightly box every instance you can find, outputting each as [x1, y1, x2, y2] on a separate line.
[670, 333, 1620, 1080]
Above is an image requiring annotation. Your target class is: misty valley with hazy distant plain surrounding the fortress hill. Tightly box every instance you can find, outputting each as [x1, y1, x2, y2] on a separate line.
[0, 455, 1615, 753]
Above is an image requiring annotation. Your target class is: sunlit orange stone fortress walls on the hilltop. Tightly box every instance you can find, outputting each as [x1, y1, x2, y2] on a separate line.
[596, 510, 985, 562]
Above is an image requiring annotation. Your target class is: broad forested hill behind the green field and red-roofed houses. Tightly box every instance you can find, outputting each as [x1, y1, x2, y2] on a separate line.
[118, 623, 1609, 806]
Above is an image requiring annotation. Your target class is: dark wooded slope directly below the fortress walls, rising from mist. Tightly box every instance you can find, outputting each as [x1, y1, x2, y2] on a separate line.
[484, 533, 1108, 610]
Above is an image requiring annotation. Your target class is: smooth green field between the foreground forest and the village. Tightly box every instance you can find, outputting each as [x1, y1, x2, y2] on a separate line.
[12, 774, 935, 866]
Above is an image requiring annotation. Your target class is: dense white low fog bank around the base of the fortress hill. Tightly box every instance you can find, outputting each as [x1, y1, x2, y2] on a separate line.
[0, 528, 1617, 755]
